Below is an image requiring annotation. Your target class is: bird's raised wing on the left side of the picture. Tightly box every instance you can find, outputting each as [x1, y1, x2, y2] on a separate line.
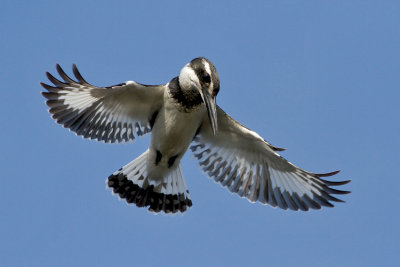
[40, 64, 165, 143]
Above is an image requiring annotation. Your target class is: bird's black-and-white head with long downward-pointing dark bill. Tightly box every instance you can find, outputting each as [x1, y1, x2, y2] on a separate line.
[179, 57, 219, 134]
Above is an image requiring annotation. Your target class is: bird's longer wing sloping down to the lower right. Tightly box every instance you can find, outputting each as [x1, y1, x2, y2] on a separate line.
[190, 107, 350, 211]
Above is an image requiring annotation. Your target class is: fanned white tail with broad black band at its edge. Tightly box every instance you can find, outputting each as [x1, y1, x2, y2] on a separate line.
[107, 150, 192, 213]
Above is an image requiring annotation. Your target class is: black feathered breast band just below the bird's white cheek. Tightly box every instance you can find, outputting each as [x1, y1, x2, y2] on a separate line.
[168, 77, 203, 110]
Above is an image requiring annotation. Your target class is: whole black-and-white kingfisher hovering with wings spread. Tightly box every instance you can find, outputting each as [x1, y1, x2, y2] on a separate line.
[41, 58, 350, 213]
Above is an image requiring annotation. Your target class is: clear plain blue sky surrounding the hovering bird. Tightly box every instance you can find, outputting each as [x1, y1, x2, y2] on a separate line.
[0, 0, 400, 266]
